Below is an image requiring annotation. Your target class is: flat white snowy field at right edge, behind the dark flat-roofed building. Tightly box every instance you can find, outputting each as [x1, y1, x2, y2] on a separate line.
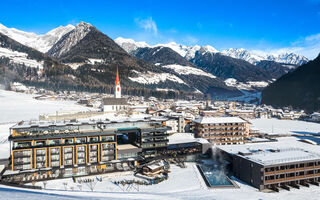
[250, 119, 320, 134]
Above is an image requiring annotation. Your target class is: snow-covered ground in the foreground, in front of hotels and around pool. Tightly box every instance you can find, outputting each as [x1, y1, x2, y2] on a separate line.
[0, 163, 320, 200]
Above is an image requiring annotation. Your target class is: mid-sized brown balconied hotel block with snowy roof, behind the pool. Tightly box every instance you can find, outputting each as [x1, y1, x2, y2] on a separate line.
[192, 117, 250, 145]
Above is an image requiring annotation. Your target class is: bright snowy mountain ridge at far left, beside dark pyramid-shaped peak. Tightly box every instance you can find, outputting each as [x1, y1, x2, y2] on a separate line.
[0, 24, 75, 53]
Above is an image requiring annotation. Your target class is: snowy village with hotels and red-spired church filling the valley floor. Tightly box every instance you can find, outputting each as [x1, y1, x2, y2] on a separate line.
[0, 66, 320, 199]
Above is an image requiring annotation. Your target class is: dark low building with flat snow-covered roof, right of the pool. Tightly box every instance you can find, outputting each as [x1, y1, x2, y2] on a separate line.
[218, 144, 320, 191]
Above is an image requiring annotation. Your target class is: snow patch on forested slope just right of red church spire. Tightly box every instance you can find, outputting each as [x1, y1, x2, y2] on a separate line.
[129, 70, 187, 85]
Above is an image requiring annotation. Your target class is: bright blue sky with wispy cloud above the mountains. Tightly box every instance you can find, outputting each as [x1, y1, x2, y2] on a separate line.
[0, 0, 320, 58]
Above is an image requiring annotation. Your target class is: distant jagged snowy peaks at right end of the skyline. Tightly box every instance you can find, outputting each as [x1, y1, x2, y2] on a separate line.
[221, 48, 308, 65]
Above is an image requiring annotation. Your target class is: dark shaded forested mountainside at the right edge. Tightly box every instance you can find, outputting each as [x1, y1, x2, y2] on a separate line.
[262, 54, 320, 112]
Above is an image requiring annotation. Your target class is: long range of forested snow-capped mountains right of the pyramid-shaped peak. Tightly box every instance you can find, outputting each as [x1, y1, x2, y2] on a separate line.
[115, 38, 302, 90]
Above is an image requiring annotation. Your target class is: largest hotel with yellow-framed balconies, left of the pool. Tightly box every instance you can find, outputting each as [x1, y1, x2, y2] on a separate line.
[3, 118, 168, 182]
